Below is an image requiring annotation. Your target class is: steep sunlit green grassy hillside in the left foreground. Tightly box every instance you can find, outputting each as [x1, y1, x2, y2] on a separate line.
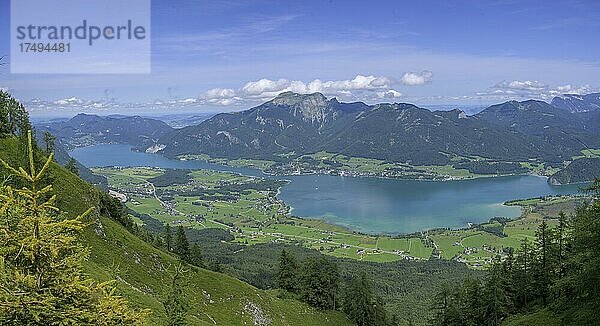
[0, 139, 351, 325]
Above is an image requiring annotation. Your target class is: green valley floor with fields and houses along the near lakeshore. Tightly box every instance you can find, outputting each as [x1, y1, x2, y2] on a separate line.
[94, 168, 582, 269]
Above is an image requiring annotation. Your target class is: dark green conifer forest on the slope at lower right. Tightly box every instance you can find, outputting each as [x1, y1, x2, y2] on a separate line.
[433, 179, 600, 325]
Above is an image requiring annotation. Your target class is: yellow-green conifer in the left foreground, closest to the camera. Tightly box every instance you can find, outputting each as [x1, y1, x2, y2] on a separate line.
[0, 131, 147, 325]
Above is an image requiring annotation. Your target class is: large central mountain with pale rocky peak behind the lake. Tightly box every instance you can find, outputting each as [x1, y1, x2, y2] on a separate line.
[152, 92, 568, 164]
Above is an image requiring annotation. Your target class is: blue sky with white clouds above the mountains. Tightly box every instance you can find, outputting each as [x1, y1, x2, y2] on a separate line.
[0, 0, 600, 114]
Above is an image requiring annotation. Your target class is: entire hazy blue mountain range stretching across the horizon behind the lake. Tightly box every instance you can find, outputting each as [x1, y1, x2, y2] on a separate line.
[36, 92, 600, 184]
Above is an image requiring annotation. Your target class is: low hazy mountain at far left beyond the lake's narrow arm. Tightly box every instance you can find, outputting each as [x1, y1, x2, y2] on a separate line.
[36, 113, 173, 149]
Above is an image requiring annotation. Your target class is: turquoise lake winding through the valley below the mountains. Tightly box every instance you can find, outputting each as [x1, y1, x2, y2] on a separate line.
[70, 144, 579, 234]
